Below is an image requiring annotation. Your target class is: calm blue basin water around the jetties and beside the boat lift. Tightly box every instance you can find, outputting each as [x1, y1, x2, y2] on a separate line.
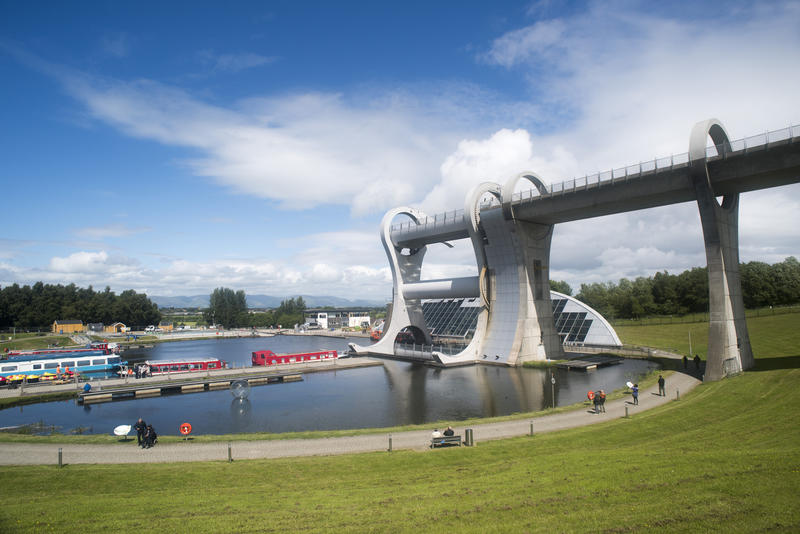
[0, 336, 656, 435]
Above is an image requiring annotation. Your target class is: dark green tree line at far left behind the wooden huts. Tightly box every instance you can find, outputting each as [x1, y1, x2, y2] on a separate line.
[0, 282, 161, 329]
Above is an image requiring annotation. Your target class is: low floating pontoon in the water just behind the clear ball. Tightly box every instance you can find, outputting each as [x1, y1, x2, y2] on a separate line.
[78, 371, 303, 404]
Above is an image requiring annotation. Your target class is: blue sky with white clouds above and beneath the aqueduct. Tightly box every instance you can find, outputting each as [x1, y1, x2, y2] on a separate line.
[0, 0, 800, 302]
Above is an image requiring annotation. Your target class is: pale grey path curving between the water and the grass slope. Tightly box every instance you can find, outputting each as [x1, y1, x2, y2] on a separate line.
[0, 372, 700, 465]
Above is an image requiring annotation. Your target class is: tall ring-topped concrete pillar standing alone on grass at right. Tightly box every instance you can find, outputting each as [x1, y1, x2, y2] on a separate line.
[689, 119, 754, 380]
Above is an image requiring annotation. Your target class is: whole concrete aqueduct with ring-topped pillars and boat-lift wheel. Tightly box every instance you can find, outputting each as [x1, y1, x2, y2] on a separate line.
[352, 119, 800, 380]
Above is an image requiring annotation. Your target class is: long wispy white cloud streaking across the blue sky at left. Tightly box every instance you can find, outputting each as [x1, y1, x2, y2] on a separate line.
[60, 73, 466, 218]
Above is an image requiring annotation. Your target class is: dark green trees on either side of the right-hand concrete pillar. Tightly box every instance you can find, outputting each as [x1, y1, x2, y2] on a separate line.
[567, 256, 800, 319]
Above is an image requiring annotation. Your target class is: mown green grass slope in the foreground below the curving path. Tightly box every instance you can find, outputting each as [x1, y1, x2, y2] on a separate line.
[0, 314, 800, 532]
